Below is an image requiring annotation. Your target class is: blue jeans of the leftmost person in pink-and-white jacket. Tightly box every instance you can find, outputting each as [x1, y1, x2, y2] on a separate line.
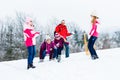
[27, 46, 36, 65]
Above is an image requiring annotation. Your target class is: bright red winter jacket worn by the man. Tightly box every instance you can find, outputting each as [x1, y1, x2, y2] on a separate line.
[55, 24, 71, 39]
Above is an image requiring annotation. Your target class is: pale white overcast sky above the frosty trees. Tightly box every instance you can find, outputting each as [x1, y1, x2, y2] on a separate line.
[0, 0, 120, 32]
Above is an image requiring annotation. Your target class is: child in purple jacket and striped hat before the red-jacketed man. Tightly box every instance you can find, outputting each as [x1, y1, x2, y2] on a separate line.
[53, 33, 64, 62]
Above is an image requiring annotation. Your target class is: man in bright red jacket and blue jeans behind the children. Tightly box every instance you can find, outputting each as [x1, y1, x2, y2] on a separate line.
[55, 20, 71, 58]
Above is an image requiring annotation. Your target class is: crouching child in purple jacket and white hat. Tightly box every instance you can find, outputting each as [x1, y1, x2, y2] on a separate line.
[39, 35, 54, 62]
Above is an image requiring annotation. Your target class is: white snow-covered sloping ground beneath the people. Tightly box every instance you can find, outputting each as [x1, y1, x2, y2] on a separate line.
[0, 48, 120, 80]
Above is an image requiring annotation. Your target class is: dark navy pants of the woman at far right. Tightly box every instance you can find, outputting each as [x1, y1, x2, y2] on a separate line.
[88, 36, 97, 57]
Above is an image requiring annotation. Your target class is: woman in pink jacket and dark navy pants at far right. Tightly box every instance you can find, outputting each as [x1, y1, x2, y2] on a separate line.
[88, 15, 99, 60]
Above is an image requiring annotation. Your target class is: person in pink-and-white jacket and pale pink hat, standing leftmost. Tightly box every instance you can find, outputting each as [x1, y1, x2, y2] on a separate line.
[23, 18, 39, 69]
